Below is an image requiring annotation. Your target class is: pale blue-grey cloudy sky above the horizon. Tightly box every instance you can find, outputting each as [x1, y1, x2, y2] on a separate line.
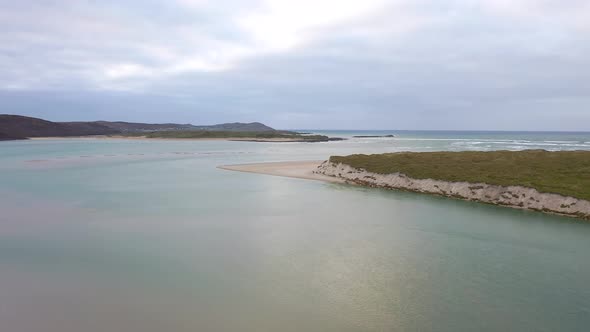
[0, 0, 590, 131]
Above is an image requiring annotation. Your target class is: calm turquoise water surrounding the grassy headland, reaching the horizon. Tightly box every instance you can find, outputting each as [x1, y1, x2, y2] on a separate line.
[0, 131, 590, 332]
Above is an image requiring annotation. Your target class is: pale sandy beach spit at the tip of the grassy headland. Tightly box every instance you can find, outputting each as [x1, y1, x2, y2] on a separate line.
[218, 160, 346, 183]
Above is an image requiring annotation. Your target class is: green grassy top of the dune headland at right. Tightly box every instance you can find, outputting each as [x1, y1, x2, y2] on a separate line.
[330, 150, 590, 200]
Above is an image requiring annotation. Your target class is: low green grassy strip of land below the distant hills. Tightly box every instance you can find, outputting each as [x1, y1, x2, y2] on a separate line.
[121, 130, 330, 142]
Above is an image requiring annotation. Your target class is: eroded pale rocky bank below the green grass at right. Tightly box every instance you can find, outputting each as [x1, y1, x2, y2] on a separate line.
[314, 161, 590, 220]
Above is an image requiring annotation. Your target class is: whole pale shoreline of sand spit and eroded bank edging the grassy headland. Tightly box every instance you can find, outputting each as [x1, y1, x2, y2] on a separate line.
[218, 161, 590, 220]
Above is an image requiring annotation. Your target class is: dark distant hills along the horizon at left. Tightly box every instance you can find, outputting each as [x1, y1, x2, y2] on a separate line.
[0, 114, 275, 140]
